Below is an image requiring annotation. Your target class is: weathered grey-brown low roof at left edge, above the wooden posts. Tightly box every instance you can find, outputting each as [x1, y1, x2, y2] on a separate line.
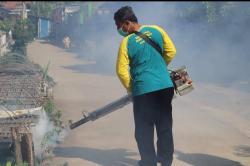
[0, 53, 43, 111]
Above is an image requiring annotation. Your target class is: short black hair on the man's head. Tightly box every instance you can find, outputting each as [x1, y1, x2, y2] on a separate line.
[114, 6, 138, 23]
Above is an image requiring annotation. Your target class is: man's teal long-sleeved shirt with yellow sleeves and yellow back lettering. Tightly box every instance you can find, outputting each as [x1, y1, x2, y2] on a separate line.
[116, 25, 176, 96]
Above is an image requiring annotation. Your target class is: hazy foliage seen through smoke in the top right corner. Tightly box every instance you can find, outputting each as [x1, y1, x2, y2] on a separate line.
[177, 1, 250, 25]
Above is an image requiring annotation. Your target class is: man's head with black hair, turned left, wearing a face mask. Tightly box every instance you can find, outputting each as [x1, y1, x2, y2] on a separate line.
[114, 6, 138, 34]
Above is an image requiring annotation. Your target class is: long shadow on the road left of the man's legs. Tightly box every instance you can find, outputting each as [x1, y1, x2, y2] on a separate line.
[54, 147, 137, 166]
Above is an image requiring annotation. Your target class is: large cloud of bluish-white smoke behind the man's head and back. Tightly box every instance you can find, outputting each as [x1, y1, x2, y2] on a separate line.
[73, 1, 250, 92]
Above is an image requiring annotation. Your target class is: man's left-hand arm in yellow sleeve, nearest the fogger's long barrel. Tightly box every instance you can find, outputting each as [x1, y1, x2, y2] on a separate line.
[116, 37, 131, 92]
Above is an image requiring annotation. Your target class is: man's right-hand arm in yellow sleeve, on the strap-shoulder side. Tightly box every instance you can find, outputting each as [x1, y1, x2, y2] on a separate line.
[150, 26, 176, 64]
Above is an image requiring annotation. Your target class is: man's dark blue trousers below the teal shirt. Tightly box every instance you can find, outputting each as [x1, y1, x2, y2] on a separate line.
[133, 88, 174, 166]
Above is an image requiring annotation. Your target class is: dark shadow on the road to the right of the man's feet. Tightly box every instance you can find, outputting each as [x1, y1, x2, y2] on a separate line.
[175, 150, 243, 166]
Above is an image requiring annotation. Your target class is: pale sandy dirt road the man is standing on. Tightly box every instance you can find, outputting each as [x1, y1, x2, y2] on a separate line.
[28, 41, 250, 166]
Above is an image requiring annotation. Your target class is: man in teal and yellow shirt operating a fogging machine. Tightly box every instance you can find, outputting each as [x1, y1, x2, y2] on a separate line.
[114, 6, 176, 166]
